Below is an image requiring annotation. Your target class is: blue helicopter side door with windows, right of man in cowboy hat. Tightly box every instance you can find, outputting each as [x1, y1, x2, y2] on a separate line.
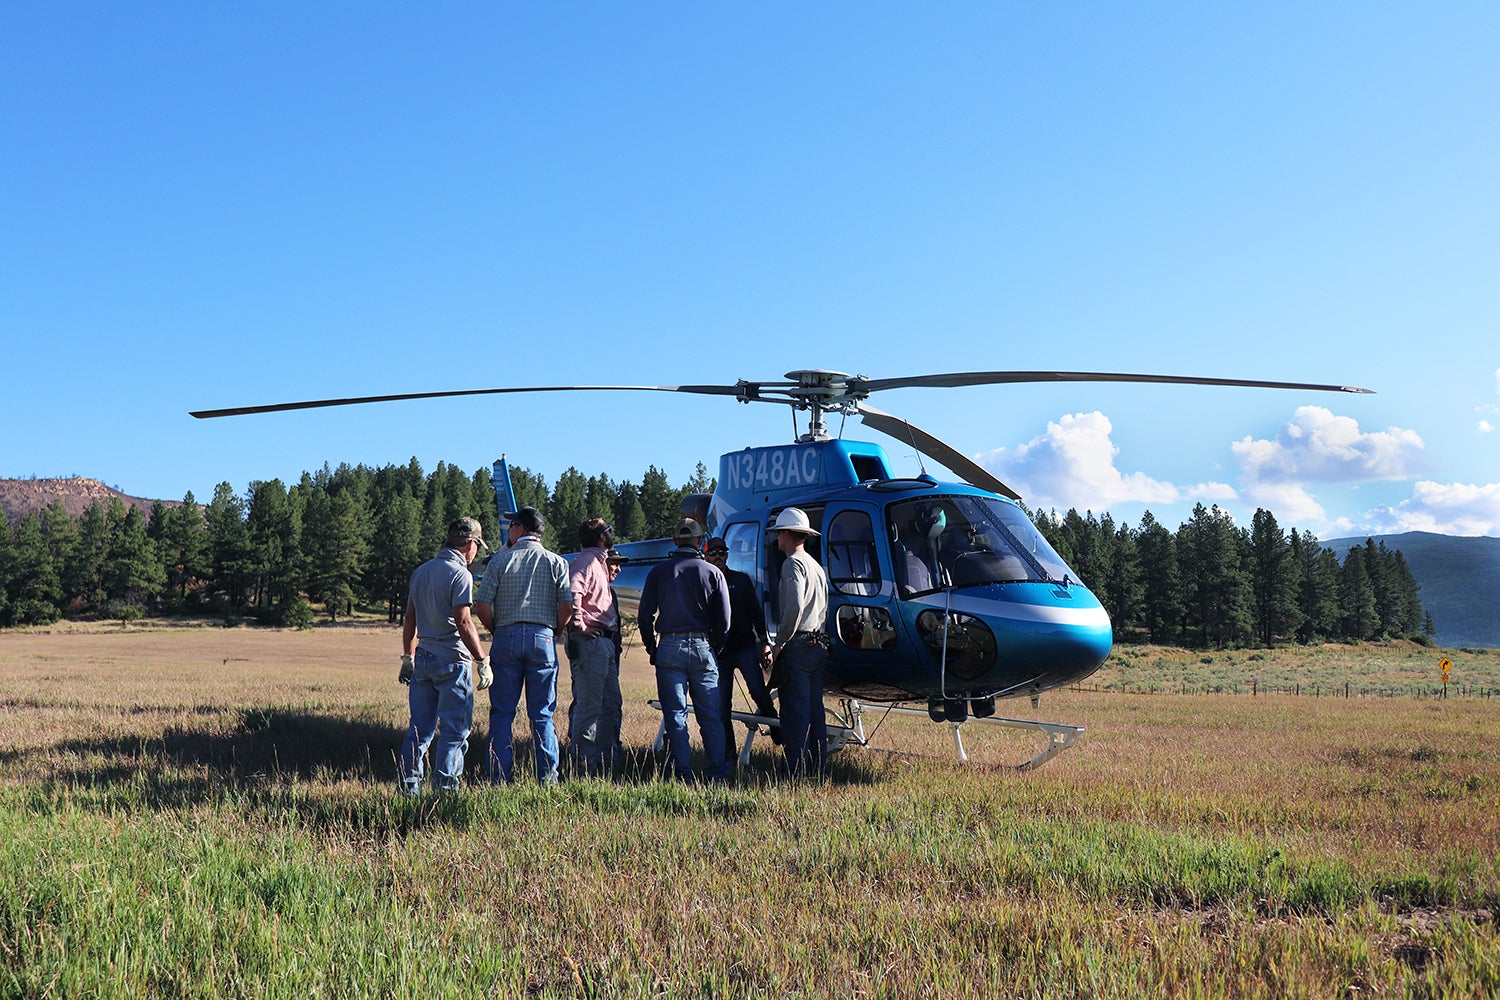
[824, 507, 897, 651]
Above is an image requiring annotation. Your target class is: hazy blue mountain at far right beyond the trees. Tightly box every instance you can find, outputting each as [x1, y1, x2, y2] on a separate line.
[1323, 531, 1500, 646]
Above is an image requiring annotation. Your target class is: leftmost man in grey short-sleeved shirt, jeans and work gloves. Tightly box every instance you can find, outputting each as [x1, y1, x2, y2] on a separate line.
[396, 517, 492, 795]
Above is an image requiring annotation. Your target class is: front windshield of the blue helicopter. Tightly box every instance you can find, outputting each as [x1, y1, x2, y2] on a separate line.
[887, 496, 1073, 594]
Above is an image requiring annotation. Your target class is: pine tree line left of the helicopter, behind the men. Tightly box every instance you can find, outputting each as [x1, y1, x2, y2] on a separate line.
[0, 459, 713, 625]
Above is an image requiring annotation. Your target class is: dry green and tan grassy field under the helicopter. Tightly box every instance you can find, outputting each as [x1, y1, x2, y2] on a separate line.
[0, 624, 1500, 999]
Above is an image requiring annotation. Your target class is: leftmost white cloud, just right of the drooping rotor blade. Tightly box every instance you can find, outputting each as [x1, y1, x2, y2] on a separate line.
[975, 411, 1194, 511]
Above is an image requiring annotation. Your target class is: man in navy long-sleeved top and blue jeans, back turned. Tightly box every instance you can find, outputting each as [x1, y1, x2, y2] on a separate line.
[638, 517, 729, 783]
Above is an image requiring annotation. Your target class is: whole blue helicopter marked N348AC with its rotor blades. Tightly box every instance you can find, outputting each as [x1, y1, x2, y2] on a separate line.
[192, 369, 1373, 769]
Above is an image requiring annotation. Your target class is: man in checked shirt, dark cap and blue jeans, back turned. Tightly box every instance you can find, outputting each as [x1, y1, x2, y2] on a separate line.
[474, 507, 573, 784]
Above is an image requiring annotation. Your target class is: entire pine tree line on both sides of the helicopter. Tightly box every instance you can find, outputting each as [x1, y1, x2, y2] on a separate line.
[0, 459, 1436, 648]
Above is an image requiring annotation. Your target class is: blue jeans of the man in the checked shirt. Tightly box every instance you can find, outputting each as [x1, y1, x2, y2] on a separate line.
[485, 622, 558, 784]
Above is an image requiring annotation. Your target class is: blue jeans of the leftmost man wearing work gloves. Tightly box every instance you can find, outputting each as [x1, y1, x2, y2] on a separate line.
[401, 648, 474, 795]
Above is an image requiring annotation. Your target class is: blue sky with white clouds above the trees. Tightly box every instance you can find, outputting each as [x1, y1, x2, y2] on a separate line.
[0, 3, 1500, 538]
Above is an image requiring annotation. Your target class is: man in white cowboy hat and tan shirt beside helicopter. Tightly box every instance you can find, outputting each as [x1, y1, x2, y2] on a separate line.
[770, 507, 828, 778]
